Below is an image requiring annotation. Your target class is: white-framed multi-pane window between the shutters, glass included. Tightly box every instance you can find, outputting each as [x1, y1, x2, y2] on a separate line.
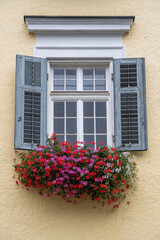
[48, 61, 113, 145]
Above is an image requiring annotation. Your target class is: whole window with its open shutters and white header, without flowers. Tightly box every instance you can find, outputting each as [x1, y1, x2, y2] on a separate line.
[15, 16, 148, 150]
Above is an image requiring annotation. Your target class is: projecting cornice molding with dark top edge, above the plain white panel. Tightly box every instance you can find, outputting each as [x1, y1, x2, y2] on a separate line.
[25, 16, 134, 35]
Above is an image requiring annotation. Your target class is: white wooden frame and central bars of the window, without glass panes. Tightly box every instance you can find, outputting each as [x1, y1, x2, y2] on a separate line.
[47, 59, 114, 146]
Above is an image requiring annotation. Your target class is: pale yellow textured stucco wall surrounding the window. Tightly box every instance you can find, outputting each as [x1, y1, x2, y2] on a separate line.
[0, 0, 160, 240]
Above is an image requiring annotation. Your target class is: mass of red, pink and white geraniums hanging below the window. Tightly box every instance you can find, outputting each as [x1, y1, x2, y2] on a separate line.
[14, 134, 136, 208]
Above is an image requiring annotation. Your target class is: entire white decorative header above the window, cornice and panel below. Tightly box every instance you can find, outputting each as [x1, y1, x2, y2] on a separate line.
[24, 16, 135, 59]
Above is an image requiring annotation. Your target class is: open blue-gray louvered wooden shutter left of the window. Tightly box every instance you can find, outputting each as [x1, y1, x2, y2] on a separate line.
[14, 55, 47, 149]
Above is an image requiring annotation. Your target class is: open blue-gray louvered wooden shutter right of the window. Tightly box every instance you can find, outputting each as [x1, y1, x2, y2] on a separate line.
[113, 58, 148, 151]
